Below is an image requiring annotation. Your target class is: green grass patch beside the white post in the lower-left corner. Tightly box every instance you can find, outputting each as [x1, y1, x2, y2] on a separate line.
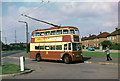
[2, 62, 27, 74]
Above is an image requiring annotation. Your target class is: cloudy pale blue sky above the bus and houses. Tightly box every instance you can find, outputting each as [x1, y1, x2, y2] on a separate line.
[0, 0, 118, 44]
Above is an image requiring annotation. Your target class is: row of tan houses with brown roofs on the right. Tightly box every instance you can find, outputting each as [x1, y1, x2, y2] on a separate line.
[81, 28, 120, 47]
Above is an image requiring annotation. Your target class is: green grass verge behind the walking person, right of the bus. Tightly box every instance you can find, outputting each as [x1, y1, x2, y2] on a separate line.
[83, 51, 120, 58]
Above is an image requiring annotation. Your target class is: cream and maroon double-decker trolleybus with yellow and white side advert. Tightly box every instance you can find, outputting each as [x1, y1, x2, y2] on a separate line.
[30, 26, 83, 63]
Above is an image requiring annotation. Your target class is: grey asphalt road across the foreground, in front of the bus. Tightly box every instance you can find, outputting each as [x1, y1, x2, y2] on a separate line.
[3, 52, 118, 79]
